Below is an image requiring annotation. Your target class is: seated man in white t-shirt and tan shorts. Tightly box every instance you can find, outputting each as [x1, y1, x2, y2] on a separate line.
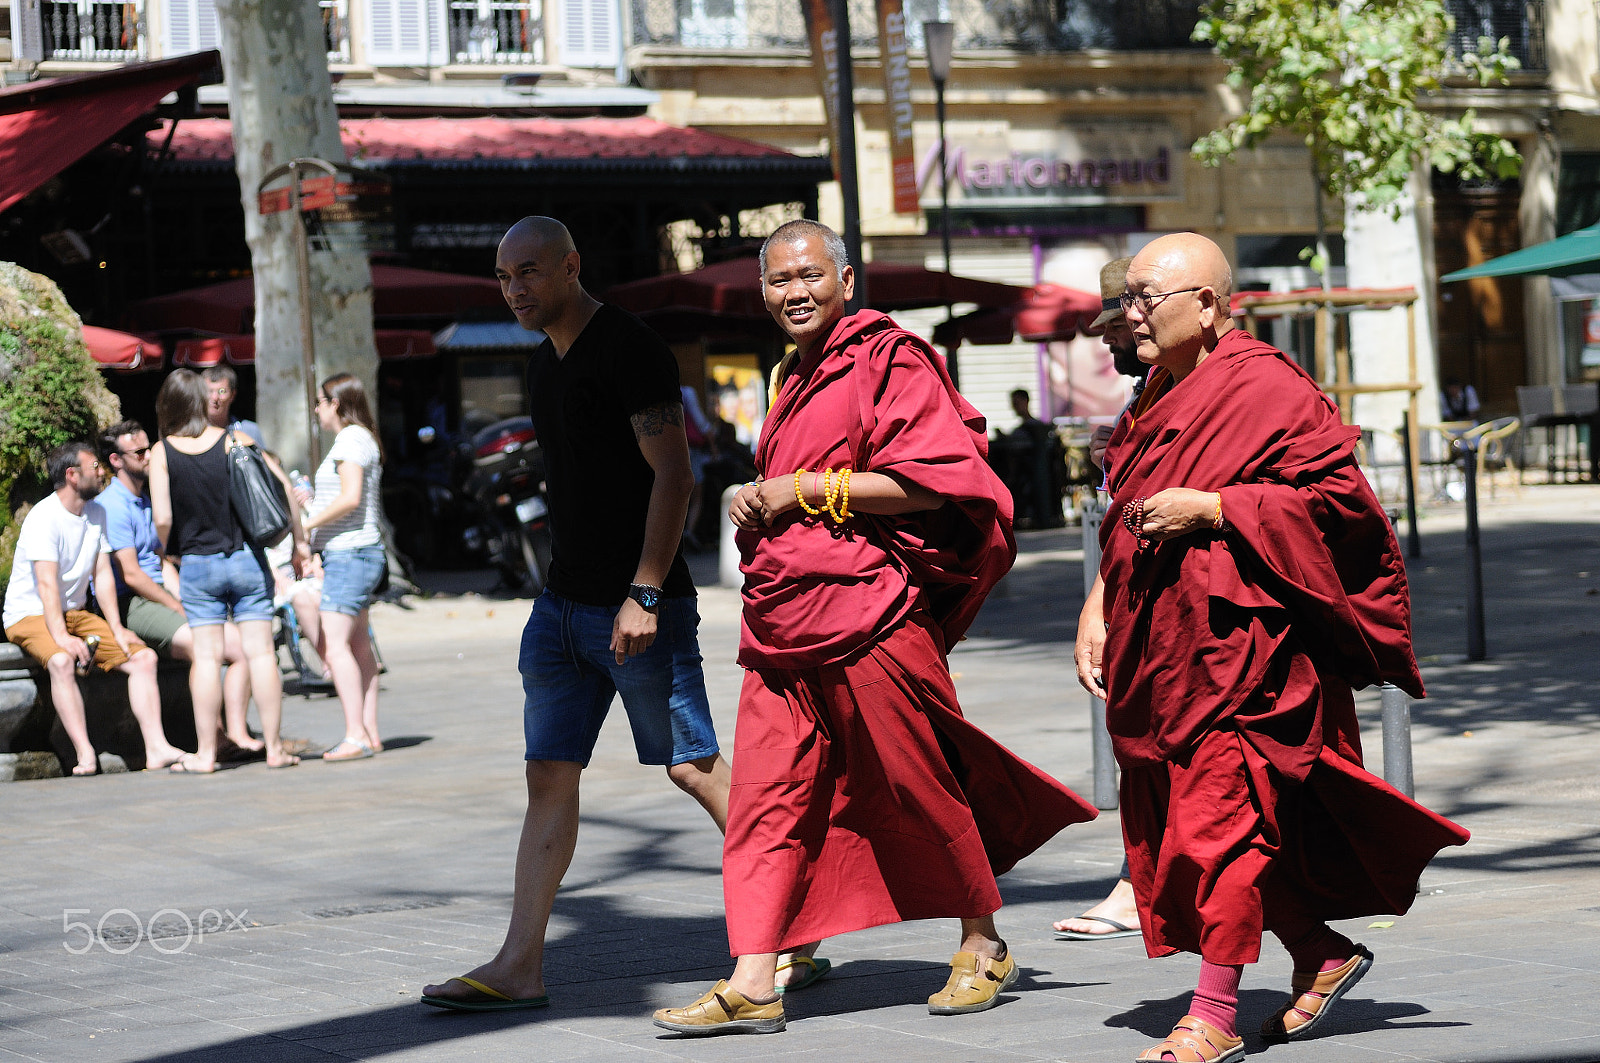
[3, 443, 184, 775]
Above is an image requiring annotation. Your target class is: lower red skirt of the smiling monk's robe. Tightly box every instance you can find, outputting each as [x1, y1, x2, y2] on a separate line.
[723, 610, 1096, 956]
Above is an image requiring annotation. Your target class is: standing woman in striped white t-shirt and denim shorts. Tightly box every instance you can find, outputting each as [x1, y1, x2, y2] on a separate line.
[296, 373, 389, 760]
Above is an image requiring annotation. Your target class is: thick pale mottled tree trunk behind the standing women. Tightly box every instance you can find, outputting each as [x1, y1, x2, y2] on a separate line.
[216, 0, 378, 471]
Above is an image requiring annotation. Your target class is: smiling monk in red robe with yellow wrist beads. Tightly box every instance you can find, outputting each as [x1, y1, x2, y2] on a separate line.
[654, 221, 1094, 1034]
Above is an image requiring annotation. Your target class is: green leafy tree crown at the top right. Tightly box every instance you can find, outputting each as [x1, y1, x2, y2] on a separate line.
[1194, 0, 1522, 215]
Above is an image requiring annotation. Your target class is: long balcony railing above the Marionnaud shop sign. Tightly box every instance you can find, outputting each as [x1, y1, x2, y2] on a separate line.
[634, 0, 1200, 54]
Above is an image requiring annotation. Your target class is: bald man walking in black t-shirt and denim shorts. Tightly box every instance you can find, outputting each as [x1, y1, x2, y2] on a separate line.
[422, 218, 730, 1012]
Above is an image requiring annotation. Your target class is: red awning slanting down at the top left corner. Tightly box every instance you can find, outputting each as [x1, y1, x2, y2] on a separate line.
[0, 51, 222, 210]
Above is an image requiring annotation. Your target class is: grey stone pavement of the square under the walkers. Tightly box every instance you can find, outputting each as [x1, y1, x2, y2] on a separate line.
[0, 487, 1600, 1063]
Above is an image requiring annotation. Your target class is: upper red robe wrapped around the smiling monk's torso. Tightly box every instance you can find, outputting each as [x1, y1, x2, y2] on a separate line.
[738, 311, 1016, 668]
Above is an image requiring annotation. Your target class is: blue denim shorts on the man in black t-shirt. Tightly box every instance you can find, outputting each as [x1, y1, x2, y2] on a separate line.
[517, 591, 717, 767]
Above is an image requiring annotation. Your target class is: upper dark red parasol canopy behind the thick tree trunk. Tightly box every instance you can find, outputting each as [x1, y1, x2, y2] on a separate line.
[123, 266, 506, 335]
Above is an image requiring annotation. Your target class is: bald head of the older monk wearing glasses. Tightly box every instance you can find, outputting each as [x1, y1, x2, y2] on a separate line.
[1128, 232, 1234, 379]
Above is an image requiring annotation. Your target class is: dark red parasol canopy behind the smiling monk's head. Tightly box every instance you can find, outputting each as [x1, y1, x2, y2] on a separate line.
[605, 258, 1024, 323]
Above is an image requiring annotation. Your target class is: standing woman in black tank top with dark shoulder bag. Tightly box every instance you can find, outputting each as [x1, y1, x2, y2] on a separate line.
[150, 370, 306, 773]
